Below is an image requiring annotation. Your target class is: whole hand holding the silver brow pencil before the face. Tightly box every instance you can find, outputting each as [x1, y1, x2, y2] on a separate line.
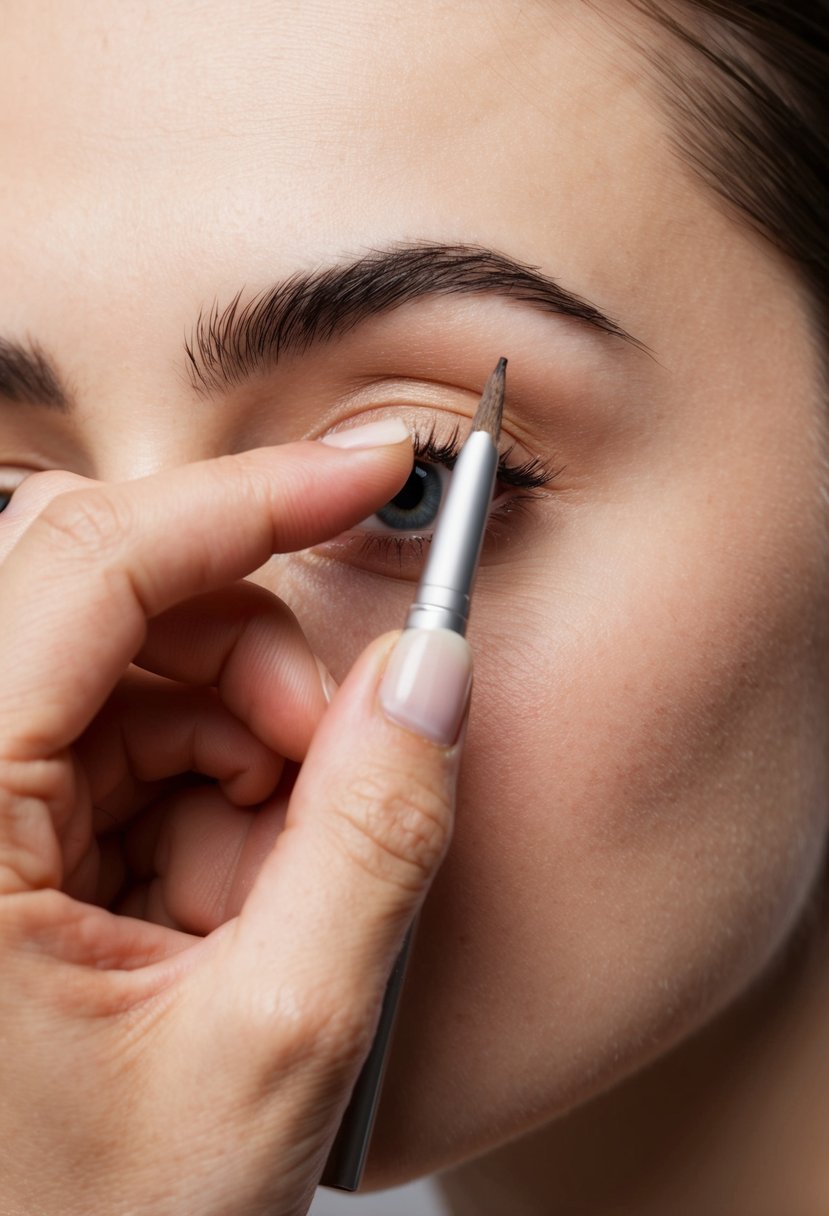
[0, 444, 469, 1216]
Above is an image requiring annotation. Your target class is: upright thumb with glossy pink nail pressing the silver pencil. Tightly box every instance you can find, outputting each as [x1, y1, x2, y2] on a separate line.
[205, 630, 472, 1066]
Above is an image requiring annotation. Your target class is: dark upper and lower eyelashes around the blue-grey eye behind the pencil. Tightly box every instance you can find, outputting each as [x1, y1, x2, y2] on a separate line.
[355, 423, 562, 565]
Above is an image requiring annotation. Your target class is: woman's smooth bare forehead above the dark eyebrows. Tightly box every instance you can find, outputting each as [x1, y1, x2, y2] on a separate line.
[0, 0, 676, 299]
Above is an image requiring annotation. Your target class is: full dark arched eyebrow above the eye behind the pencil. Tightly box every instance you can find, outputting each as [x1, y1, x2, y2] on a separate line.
[185, 242, 649, 394]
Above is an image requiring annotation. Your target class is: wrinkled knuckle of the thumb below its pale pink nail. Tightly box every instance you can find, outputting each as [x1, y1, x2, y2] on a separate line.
[335, 766, 451, 890]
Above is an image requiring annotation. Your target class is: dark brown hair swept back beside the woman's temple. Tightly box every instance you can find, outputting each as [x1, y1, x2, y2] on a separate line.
[631, 0, 829, 338]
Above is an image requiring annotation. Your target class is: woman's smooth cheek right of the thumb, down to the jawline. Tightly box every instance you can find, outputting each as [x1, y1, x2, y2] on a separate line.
[367, 483, 827, 1169]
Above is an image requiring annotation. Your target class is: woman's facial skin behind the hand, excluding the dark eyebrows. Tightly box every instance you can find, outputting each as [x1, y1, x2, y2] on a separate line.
[0, 0, 827, 1184]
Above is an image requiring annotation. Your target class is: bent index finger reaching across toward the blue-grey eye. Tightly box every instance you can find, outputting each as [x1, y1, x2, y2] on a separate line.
[0, 430, 412, 761]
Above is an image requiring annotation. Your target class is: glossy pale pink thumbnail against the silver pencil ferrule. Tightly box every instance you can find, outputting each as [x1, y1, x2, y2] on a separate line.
[379, 629, 472, 747]
